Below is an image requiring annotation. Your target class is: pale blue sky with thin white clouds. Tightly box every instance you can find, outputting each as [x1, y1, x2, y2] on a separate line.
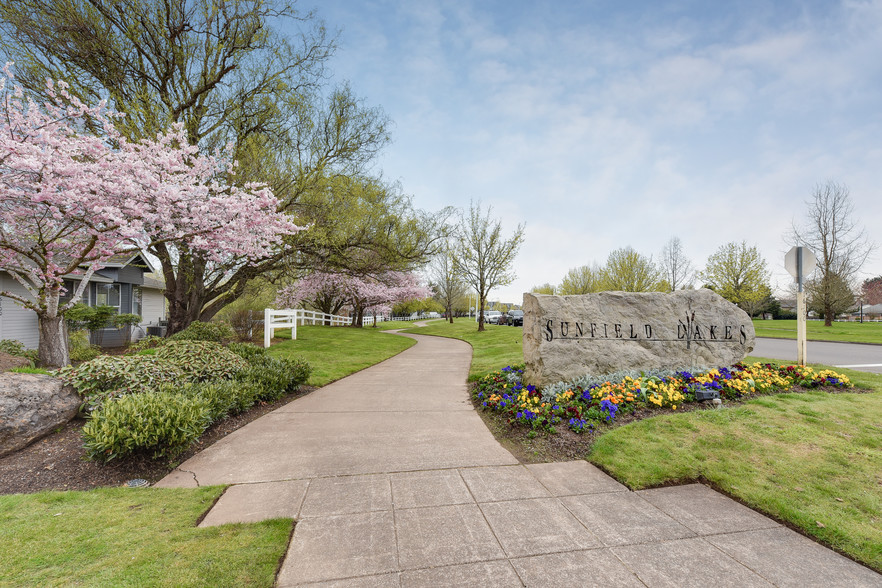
[298, 0, 882, 302]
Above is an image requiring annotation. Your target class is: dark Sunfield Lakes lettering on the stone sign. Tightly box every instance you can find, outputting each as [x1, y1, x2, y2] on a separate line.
[543, 317, 748, 345]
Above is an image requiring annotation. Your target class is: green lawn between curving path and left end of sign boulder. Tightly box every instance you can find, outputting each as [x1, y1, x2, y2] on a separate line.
[407, 318, 524, 381]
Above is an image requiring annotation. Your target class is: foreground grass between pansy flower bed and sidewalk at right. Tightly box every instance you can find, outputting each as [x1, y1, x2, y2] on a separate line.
[588, 370, 882, 571]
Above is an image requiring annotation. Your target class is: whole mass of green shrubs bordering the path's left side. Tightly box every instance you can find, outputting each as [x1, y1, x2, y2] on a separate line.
[73, 340, 311, 461]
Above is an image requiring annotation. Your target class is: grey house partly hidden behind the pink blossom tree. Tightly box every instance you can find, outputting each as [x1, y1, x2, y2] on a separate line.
[0, 253, 166, 349]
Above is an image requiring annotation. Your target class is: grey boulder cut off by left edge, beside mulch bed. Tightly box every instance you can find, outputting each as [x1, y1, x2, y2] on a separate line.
[0, 373, 81, 457]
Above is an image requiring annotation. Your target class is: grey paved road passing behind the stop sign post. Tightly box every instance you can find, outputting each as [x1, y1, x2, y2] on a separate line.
[751, 337, 882, 374]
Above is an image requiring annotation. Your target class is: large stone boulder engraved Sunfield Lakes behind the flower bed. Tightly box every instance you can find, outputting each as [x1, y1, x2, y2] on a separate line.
[524, 289, 755, 386]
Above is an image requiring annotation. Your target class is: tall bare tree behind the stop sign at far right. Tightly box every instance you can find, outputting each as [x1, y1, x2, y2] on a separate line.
[790, 181, 875, 327]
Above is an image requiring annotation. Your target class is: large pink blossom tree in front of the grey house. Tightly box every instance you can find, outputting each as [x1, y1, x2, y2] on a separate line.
[0, 64, 300, 366]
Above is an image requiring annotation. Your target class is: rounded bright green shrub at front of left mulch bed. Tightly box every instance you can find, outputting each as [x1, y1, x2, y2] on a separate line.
[83, 392, 211, 462]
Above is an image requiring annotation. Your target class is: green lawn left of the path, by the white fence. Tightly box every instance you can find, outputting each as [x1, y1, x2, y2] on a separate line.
[269, 323, 415, 386]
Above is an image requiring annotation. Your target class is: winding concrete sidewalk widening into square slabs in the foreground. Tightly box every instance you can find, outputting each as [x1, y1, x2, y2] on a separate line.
[157, 337, 882, 587]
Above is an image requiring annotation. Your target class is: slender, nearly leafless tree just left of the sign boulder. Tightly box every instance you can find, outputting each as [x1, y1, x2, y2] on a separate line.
[452, 202, 524, 331]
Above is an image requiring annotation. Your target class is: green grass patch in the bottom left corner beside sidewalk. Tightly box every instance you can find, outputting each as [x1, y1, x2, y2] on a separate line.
[0, 486, 293, 587]
